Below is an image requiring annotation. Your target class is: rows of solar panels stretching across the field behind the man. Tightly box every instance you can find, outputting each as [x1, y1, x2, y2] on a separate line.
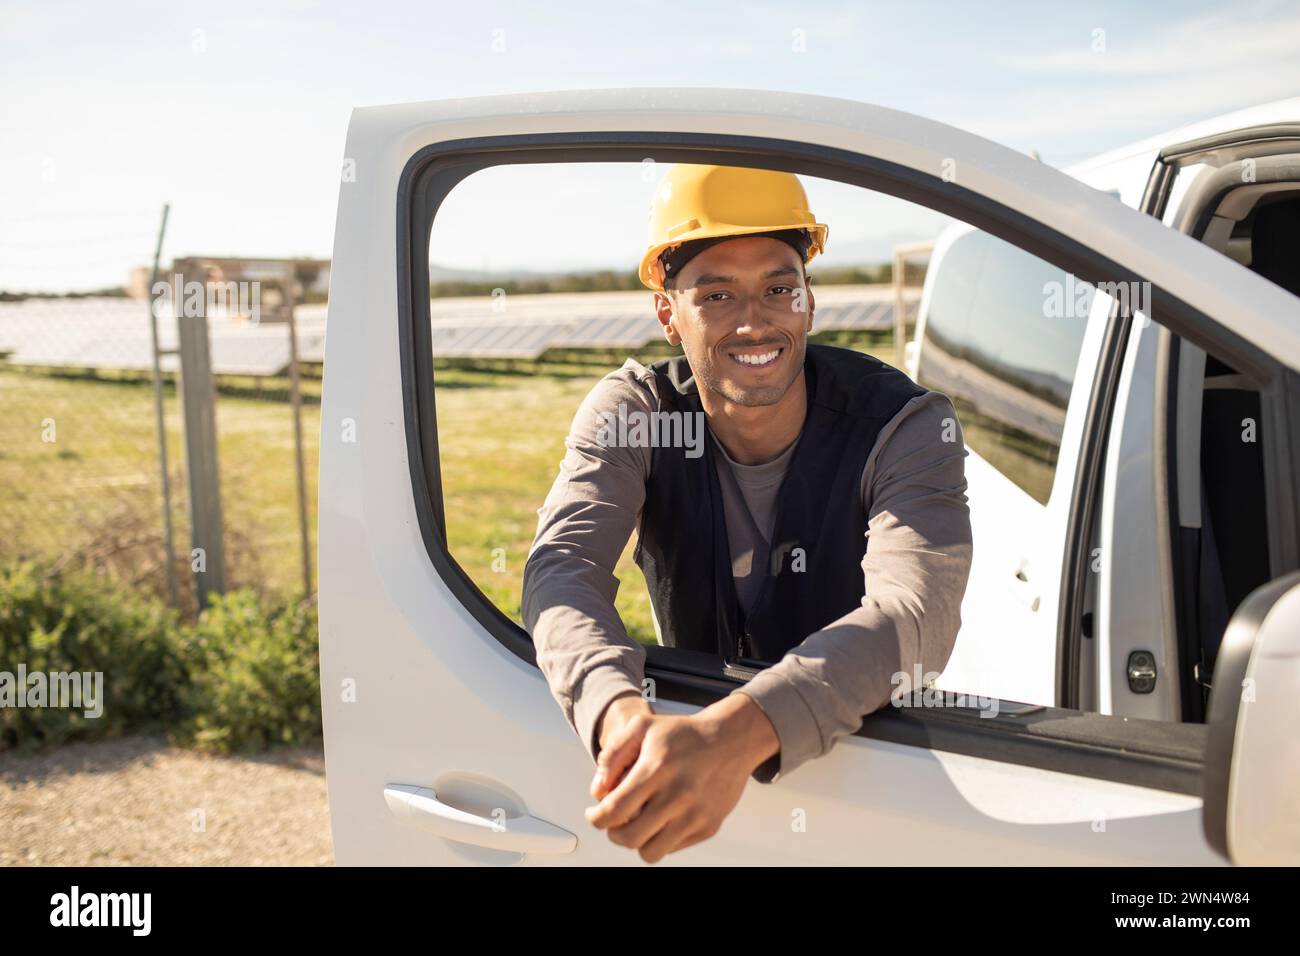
[0, 286, 917, 376]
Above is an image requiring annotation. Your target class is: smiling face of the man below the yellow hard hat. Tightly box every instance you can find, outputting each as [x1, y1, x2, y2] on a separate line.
[655, 235, 813, 406]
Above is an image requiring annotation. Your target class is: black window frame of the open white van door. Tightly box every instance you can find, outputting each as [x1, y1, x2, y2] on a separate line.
[395, 130, 1300, 795]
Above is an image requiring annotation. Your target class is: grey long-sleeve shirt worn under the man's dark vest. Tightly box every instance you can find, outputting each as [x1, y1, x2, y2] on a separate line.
[523, 359, 971, 783]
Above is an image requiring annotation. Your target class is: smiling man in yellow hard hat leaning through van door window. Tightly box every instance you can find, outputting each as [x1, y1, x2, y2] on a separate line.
[523, 165, 971, 862]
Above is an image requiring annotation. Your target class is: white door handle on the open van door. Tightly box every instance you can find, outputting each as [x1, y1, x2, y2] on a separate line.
[384, 783, 577, 856]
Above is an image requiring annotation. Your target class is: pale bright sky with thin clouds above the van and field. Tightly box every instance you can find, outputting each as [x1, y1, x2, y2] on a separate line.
[0, 0, 1300, 291]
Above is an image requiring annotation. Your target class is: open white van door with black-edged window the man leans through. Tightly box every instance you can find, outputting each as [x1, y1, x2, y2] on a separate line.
[319, 90, 1300, 865]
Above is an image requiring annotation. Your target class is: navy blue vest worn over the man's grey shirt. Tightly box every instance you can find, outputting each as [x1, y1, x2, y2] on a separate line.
[634, 345, 937, 662]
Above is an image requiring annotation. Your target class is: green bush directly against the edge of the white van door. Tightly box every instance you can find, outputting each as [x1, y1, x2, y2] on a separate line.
[177, 589, 321, 752]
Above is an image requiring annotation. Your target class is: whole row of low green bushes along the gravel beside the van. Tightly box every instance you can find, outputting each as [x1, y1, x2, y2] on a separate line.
[0, 562, 321, 752]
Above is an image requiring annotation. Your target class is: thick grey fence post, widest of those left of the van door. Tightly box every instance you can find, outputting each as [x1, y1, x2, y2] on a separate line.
[177, 257, 226, 611]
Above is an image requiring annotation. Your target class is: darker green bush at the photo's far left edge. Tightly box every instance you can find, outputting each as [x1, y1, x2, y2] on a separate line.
[0, 562, 189, 750]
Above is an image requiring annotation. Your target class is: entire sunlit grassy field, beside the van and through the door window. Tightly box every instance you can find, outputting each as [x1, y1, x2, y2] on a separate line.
[0, 332, 888, 643]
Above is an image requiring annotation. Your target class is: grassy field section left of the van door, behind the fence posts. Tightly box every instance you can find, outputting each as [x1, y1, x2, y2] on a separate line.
[0, 368, 320, 606]
